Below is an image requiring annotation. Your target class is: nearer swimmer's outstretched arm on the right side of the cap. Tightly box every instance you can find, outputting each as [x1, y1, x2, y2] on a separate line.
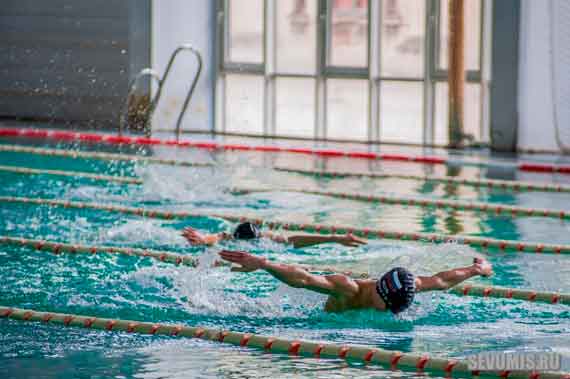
[416, 258, 493, 292]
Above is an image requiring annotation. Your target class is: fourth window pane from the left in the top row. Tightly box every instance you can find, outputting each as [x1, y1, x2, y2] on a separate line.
[380, 0, 426, 78]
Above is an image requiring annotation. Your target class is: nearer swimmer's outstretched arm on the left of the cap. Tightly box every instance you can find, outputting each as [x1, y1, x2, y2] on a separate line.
[220, 250, 358, 296]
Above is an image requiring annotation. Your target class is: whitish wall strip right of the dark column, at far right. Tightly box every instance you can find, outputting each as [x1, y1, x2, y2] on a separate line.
[518, 0, 570, 151]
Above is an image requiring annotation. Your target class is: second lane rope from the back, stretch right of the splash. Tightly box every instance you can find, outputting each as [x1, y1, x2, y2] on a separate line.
[274, 167, 570, 192]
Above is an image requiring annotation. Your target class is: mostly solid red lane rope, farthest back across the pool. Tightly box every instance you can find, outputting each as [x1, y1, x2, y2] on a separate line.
[0, 128, 570, 174]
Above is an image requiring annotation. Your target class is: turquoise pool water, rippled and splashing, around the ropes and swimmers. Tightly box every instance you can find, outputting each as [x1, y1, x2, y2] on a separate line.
[0, 139, 570, 378]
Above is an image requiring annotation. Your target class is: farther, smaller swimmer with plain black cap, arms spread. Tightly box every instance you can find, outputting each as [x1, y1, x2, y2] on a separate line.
[182, 222, 366, 248]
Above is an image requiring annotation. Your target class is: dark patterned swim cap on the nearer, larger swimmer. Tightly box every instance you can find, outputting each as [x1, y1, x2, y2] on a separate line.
[376, 267, 416, 314]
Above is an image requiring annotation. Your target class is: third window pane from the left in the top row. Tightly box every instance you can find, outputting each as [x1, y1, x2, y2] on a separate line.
[327, 0, 368, 67]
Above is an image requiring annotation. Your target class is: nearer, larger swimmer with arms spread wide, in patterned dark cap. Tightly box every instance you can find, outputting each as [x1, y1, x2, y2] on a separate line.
[215, 250, 493, 314]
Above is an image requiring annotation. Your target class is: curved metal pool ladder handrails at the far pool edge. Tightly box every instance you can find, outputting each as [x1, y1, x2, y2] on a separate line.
[119, 44, 202, 141]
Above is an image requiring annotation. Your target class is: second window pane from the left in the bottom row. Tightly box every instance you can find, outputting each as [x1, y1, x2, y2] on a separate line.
[275, 78, 315, 137]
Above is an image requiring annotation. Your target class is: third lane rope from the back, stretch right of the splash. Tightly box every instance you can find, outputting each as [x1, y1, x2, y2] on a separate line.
[233, 187, 570, 223]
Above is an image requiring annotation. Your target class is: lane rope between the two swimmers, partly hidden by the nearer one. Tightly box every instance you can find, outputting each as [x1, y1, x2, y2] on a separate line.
[0, 236, 570, 305]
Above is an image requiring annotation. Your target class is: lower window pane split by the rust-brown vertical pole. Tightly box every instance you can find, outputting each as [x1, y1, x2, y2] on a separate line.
[434, 83, 481, 144]
